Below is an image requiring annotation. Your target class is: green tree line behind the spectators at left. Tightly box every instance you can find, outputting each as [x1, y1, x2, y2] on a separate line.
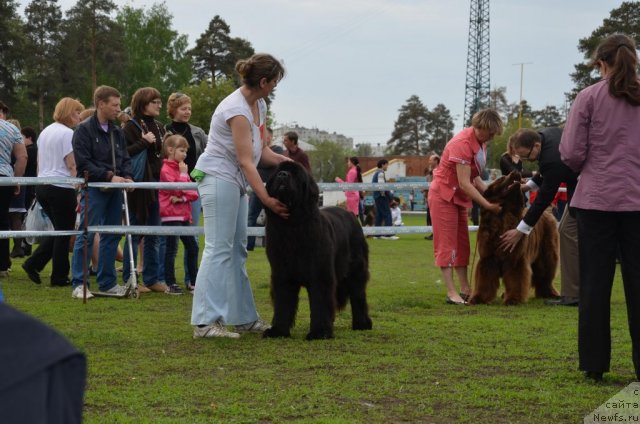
[0, 0, 254, 129]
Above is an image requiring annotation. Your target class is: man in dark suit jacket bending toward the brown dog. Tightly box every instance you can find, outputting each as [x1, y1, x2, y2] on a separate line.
[501, 128, 580, 306]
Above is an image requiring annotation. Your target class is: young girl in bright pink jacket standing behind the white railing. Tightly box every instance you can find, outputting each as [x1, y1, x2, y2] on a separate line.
[158, 135, 198, 294]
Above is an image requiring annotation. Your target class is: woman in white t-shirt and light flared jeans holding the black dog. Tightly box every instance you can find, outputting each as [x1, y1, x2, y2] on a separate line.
[191, 54, 289, 338]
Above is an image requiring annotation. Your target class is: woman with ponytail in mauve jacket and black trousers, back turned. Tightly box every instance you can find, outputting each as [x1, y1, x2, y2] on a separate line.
[560, 34, 640, 381]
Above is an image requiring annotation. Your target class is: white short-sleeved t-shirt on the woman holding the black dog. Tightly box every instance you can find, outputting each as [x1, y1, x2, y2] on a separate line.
[196, 89, 267, 192]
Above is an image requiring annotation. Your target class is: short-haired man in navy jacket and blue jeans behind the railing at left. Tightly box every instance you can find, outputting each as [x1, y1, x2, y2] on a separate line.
[71, 85, 133, 299]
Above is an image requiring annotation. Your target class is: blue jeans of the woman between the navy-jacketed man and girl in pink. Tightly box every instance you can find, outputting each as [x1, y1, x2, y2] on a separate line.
[122, 200, 164, 286]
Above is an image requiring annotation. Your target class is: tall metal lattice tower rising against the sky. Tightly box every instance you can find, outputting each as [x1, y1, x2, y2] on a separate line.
[464, 0, 491, 126]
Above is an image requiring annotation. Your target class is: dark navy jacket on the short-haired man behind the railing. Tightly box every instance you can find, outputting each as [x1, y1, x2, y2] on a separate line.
[71, 114, 132, 182]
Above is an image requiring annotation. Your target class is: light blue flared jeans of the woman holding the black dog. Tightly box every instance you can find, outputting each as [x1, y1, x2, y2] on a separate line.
[191, 175, 258, 325]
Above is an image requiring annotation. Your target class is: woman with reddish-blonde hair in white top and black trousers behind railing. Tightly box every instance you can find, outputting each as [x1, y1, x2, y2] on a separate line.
[22, 97, 84, 286]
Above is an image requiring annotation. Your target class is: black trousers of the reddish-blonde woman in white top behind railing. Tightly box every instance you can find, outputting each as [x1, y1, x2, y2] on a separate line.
[24, 186, 77, 285]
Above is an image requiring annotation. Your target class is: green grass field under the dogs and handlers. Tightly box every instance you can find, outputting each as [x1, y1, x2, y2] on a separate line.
[0, 216, 635, 423]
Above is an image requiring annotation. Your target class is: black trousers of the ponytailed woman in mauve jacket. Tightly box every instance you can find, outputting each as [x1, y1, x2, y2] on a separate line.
[577, 209, 640, 379]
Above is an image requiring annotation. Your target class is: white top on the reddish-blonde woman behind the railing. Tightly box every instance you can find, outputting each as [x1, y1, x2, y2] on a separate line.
[38, 122, 75, 188]
